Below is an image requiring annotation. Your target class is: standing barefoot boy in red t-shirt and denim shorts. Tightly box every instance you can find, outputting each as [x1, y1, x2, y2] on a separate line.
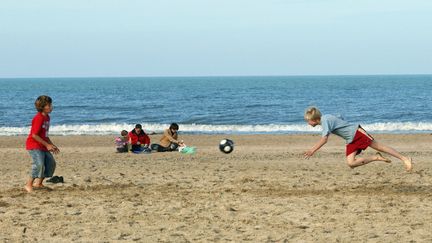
[24, 95, 60, 192]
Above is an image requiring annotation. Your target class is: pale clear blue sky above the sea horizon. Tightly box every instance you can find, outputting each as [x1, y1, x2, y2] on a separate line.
[0, 0, 432, 77]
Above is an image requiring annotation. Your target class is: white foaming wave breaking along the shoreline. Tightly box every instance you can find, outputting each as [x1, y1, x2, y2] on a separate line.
[0, 122, 432, 136]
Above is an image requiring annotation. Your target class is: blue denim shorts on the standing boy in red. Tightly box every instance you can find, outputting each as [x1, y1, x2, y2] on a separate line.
[28, 149, 56, 178]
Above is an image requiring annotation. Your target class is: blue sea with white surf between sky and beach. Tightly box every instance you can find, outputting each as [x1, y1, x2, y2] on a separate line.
[0, 75, 432, 136]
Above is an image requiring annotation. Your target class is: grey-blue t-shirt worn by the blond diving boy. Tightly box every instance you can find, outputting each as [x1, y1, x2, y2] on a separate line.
[321, 115, 359, 144]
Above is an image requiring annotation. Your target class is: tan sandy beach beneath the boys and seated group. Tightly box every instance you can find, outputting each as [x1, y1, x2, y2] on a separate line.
[0, 134, 432, 242]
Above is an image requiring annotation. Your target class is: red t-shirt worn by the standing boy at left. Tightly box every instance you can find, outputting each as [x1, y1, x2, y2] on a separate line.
[26, 112, 50, 151]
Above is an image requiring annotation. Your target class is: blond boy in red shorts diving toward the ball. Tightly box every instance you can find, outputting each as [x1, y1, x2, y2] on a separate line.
[304, 107, 413, 171]
